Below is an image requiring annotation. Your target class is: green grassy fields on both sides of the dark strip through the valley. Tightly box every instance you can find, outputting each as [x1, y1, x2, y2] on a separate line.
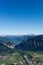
[0, 51, 43, 65]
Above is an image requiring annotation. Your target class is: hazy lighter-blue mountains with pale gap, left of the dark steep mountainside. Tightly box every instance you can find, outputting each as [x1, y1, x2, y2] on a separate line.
[0, 36, 27, 52]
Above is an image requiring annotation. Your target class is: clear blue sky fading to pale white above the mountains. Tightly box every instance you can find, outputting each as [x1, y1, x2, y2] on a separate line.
[0, 0, 43, 35]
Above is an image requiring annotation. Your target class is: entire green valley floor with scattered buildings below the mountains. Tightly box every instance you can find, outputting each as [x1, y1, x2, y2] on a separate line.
[0, 50, 43, 65]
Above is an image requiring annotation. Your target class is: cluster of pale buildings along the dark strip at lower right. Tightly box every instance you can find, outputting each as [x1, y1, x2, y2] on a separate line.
[11, 54, 43, 65]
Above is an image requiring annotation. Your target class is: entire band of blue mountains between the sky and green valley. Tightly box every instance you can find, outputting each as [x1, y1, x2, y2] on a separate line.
[0, 35, 43, 52]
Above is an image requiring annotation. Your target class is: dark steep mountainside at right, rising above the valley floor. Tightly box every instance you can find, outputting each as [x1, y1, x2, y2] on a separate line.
[16, 35, 43, 51]
